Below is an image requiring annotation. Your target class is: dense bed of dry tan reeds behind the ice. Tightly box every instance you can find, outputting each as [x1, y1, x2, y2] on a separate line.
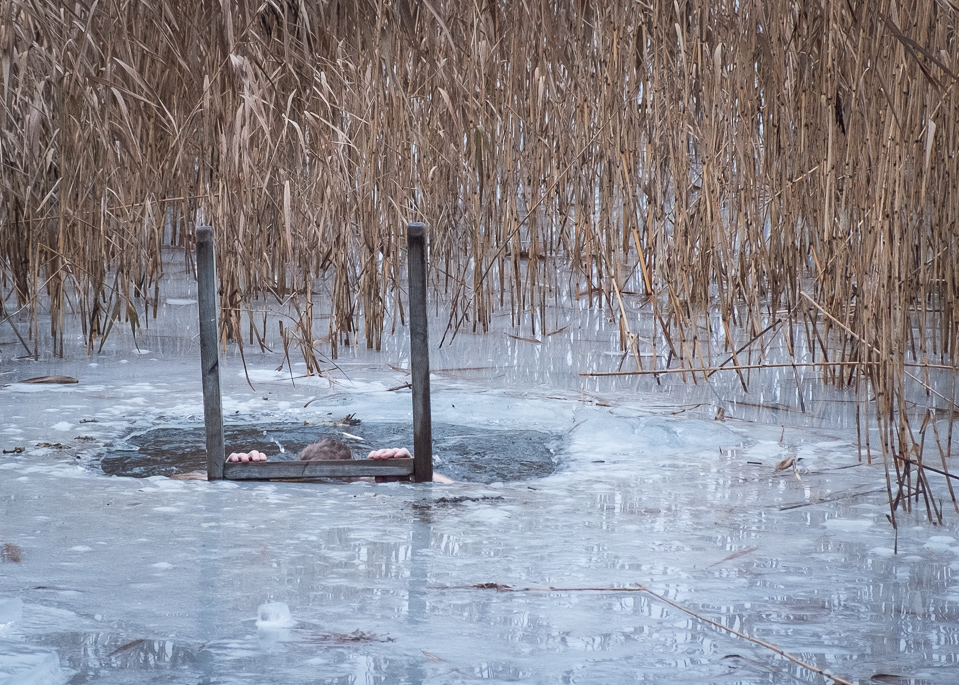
[0, 0, 959, 520]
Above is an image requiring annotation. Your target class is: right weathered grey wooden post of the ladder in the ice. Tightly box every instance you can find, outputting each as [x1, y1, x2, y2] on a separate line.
[406, 223, 433, 483]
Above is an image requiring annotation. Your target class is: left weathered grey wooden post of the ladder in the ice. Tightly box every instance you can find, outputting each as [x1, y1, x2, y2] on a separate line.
[196, 226, 226, 480]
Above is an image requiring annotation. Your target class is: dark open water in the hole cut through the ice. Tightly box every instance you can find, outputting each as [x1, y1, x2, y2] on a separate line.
[99, 423, 559, 483]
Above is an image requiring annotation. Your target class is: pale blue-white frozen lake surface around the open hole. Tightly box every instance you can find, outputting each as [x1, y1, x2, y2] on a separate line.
[0, 280, 959, 685]
